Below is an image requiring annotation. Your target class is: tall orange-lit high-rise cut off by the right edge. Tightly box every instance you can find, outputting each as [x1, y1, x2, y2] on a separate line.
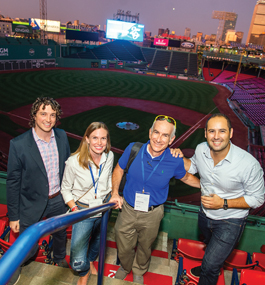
[246, 0, 265, 44]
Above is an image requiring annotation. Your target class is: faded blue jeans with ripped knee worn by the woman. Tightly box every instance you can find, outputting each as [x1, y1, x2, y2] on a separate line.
[70, 206, 101, 277]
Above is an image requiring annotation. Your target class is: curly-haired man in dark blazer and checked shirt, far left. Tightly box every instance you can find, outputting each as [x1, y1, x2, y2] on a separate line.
[6, 97, 70, 284]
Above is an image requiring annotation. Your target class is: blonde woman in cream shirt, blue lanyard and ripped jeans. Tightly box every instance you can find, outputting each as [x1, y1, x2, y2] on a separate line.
[61, 122, 113, 285]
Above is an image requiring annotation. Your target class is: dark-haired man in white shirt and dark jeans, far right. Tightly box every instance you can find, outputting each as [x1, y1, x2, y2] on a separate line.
[178, 114, 264, 285]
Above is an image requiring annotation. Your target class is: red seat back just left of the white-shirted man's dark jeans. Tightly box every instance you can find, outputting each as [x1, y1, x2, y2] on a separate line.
[177, 238, 206, 261]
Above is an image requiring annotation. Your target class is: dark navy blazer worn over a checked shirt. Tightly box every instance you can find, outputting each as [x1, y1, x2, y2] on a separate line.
[6, 128, 70, 225]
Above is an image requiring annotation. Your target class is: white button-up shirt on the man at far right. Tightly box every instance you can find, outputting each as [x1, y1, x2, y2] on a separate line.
[188, 142, 264, 220]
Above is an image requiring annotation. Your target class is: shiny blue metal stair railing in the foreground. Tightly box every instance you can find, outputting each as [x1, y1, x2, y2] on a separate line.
[0, 203, 115, 285]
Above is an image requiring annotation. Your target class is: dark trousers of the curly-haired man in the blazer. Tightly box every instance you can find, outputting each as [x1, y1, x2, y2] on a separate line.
[19, 194, 67, 263]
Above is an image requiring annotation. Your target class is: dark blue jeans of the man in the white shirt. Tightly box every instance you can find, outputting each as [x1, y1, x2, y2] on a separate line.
[198, 206, 247, 285]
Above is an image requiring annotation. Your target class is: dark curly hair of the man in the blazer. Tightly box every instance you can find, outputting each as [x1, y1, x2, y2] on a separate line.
[29, 97, 63, 128]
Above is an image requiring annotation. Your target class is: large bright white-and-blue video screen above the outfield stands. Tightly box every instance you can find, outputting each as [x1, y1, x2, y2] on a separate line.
[106, 20, 144, 42]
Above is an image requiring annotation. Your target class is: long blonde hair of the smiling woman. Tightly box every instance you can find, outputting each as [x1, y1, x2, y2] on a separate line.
[72, 122, 111, 169]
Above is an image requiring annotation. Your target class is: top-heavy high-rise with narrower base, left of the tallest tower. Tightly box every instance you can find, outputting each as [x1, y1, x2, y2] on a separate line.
[212, 11, 237, 44]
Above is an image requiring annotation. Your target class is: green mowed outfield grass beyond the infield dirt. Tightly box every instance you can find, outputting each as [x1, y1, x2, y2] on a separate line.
[0, 70, 218, 114]
